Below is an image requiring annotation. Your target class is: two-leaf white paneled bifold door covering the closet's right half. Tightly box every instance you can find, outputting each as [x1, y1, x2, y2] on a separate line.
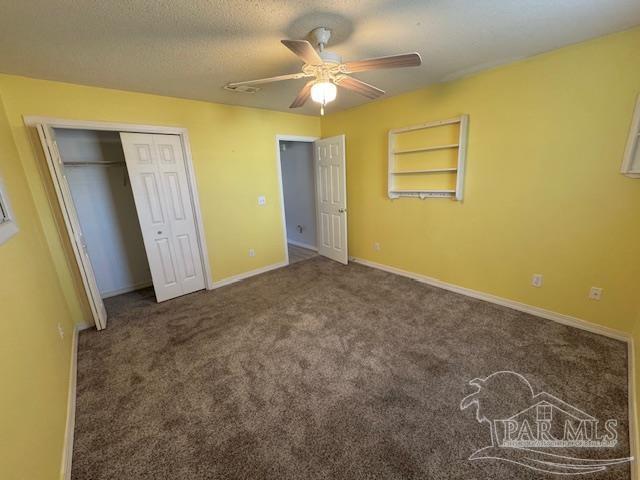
[120, 133, 204, 302]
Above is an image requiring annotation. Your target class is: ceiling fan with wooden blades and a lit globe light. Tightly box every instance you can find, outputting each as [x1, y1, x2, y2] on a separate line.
[225, 27, 422, 115]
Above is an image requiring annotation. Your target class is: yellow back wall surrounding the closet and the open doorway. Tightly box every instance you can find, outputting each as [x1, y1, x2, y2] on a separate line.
[0, 75, 320, 324]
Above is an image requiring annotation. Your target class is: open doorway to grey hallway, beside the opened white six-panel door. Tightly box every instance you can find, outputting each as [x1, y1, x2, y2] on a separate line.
[278, 140, 318, 264]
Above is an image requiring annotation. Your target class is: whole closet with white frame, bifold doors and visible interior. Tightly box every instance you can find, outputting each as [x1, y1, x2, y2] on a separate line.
[25, 117, 213, 330]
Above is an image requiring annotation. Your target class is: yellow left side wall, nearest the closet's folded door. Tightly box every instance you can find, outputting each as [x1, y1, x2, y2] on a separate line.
[0, 92, 73, 480]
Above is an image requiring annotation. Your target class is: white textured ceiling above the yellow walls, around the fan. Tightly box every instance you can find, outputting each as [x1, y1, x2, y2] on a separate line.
[0, 0, 640, 114]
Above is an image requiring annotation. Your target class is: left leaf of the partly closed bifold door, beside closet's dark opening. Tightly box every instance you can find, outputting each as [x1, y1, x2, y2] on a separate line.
[120, 133, 186, 302]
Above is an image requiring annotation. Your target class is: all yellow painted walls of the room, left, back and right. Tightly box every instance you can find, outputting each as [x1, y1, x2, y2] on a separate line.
[0, 29, 640, 480]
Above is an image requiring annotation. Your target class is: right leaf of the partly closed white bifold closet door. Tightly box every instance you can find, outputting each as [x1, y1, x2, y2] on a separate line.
[153, 135, 204, 293]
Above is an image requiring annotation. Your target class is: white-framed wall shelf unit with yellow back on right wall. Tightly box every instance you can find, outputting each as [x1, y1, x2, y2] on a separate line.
[387, 115, 469, 200]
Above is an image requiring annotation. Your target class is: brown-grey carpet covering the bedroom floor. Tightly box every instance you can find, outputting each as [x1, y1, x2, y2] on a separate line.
[73, 257, 630, 480]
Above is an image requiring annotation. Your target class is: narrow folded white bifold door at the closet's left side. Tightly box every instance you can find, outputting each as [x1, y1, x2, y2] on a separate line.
[36, 124, 107, 330]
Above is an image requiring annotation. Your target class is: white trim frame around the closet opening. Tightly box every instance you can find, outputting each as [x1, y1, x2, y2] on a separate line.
[24, 116, 215, 325]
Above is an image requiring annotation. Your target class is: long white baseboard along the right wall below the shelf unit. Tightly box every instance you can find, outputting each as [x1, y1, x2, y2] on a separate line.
[349, 257, 632, 343]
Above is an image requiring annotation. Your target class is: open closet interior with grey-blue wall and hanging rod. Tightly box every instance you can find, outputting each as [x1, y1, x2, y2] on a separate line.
[53, 128, 153, 308]
